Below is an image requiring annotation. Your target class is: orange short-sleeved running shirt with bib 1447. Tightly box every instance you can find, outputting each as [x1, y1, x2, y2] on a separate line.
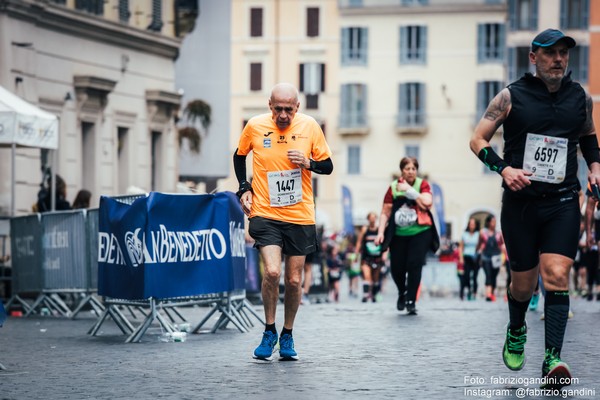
[237, 113, 331, 225]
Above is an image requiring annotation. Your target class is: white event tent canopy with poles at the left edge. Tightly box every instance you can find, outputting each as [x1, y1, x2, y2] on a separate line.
[0, 86, 58, 216]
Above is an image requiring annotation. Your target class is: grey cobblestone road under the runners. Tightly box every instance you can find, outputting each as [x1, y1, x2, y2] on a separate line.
[0, 294, 600, 400]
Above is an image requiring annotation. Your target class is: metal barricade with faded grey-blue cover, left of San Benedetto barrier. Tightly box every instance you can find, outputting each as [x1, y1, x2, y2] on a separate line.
[7, 210, 118, 317]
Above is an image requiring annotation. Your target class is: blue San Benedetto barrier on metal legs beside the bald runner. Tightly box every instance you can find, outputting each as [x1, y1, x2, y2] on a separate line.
[88, 192, 255, 342]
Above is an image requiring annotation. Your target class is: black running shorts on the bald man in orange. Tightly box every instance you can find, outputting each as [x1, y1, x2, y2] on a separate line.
[248, 217, 317, 256]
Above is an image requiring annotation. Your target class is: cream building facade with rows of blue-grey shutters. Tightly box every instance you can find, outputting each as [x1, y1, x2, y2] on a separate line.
[338, 0, 507, 239]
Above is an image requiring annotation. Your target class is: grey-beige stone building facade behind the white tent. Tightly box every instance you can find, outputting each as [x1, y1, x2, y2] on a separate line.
[0, 0, 189, 214]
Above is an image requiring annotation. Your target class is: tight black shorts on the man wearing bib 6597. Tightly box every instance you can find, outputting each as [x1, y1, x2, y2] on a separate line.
[500, 191, 581, 271]
